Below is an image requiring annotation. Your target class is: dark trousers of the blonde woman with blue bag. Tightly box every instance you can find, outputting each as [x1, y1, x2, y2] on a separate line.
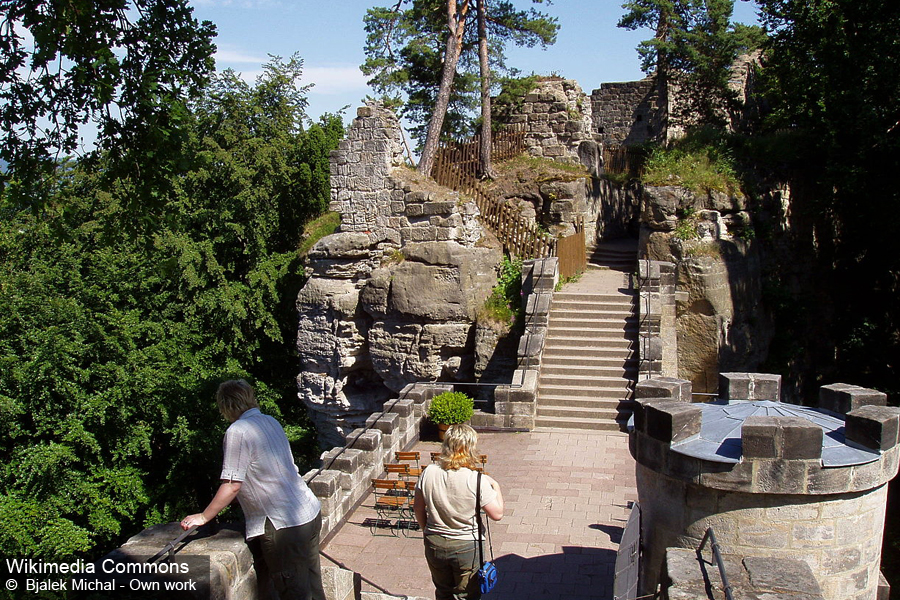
[425, 534, 481, 600]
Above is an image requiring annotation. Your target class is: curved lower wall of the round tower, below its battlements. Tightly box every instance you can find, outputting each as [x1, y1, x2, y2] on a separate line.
[636, 464, 887, 600]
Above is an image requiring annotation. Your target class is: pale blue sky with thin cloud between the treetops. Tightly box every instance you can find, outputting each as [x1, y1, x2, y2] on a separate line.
[191, 0, 755, 119]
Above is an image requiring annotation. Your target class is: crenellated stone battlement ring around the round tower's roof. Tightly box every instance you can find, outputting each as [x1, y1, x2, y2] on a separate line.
[632, 373, 900, 494]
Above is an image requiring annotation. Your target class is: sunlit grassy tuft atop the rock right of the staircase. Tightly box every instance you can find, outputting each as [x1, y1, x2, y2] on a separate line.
[641, 128, 740, 194]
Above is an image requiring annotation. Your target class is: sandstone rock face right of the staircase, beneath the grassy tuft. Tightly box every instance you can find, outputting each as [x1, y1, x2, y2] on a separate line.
[640, 186, 774, 393]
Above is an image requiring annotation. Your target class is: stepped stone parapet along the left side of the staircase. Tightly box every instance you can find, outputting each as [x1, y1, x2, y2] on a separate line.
[472, 257, 559, 430]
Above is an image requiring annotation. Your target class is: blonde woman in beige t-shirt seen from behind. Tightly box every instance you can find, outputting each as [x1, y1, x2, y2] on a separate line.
[413, 424, 503, 600]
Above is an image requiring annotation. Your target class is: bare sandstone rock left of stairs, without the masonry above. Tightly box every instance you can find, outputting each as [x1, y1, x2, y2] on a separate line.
[297, 239, 501, 442]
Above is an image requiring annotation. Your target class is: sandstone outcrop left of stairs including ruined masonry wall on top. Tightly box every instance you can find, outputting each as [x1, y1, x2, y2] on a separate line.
[297, 106, 501, 446]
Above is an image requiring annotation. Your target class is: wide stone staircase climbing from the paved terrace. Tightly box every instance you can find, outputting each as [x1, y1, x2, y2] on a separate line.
[535, 239, 638, 430]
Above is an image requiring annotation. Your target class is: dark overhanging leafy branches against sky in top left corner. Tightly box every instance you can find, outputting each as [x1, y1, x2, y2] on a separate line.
[0, 0, 215, 204]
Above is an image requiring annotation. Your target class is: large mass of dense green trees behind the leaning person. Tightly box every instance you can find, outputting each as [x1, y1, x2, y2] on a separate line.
[0, 57, 342, 557]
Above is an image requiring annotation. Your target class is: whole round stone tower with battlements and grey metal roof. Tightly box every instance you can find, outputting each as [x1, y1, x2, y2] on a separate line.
[630, 373, 900, 600]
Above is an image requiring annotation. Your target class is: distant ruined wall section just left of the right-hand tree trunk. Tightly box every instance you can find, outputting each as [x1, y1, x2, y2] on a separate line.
[591, 78, 662, 145]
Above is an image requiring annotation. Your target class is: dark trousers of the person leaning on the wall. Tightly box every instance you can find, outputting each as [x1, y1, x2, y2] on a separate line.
[251, 513, 326, 600]
